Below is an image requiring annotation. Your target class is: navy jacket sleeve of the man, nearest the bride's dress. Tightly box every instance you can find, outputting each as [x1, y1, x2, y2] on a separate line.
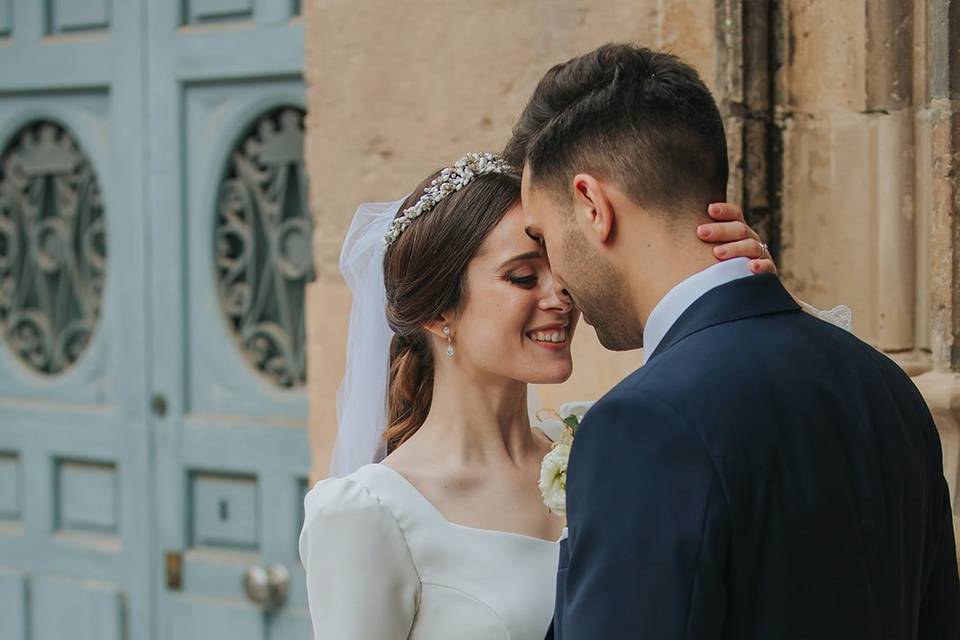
[557, 392, 730, 640]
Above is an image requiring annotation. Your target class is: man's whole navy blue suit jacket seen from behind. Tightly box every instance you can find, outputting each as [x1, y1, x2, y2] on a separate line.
[548, 275, 960, 640]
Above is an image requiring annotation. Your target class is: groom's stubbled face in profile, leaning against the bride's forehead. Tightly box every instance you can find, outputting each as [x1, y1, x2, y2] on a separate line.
[521, 168, 643, 351]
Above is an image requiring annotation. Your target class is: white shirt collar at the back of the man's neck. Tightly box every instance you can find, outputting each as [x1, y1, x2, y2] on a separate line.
[643, 258, 753, 364]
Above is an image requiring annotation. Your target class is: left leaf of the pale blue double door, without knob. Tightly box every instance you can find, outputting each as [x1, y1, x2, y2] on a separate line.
[0, 0, 153, 640]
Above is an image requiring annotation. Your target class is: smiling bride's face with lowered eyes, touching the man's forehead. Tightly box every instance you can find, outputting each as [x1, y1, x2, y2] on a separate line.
[454, 202, 579, 383]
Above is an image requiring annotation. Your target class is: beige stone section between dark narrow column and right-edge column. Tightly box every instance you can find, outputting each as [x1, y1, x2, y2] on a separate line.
[777, 0, 916, 353]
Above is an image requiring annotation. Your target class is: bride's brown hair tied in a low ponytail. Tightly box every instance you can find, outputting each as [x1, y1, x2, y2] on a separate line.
[383, 171, 520, 453]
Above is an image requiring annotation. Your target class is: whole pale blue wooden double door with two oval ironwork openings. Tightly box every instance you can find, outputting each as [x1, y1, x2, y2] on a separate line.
[0, 0, 311, 640]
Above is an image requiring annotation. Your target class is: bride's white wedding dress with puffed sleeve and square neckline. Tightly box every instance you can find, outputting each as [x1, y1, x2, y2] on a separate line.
[300, 456, 560, 640]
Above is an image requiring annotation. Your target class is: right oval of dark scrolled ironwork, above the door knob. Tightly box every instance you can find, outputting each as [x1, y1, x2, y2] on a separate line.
[214, 107, 313, 388]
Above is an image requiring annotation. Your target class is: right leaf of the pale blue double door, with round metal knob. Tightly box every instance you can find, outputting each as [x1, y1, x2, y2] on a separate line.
[146, 0, 312, 640]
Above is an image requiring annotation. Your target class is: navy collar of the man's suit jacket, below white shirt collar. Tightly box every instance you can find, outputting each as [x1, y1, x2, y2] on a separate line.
[646, 274, 800, 362]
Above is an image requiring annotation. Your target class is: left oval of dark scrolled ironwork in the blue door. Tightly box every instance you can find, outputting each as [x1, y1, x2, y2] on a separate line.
[0, 121, 107, 375]
